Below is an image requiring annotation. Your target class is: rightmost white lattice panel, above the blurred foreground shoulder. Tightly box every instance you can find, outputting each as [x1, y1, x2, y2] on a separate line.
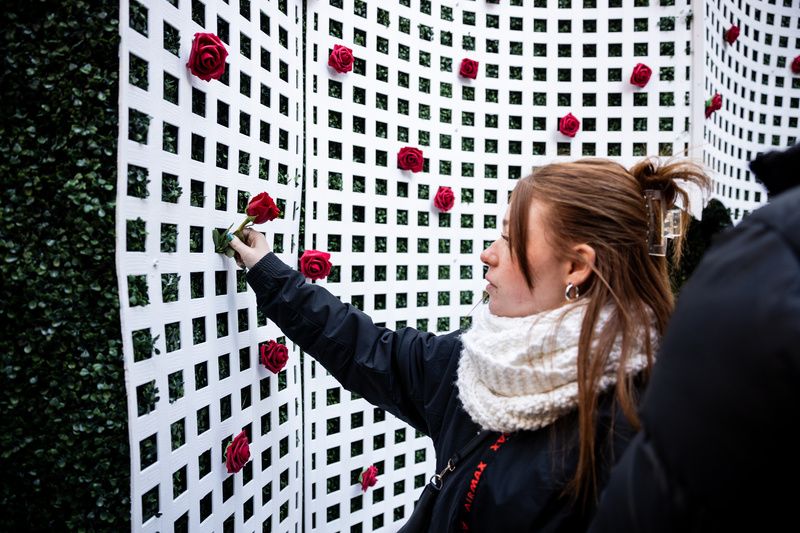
[703, 0, 800, 222]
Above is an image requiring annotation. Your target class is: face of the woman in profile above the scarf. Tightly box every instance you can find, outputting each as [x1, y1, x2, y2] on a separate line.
[481, 200, 570, 317]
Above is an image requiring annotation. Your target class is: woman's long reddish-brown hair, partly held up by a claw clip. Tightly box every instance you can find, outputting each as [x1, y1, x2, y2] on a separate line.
[509, 158, 709, 502]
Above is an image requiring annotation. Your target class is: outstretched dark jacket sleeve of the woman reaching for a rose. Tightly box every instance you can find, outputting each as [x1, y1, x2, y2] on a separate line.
[247, 253, 460, 437]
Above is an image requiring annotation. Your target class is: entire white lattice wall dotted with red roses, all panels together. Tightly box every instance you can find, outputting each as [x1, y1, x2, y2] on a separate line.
[112, 0, 800, 531]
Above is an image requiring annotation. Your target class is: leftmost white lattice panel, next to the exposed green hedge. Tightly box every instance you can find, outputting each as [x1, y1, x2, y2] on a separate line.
[117, 0, 303, 531]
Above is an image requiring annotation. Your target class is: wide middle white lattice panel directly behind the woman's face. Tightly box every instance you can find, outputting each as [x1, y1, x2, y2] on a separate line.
[305, 0, 692, 531]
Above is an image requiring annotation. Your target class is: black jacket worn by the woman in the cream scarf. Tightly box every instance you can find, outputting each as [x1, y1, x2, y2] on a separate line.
[247, 253, 633, 533]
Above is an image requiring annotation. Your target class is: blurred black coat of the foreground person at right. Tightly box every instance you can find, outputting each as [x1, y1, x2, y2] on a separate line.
[592, 185, 800, 532]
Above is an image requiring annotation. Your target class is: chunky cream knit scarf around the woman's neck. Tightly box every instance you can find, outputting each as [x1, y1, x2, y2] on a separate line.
[456, 302, 657, 432]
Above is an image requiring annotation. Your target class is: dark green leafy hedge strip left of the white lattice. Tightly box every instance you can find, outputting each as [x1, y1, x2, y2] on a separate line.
[0, 0, 130, 531]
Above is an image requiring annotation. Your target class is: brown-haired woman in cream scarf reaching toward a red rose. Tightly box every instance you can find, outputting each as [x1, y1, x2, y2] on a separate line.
[231, 159, 708, 532]
